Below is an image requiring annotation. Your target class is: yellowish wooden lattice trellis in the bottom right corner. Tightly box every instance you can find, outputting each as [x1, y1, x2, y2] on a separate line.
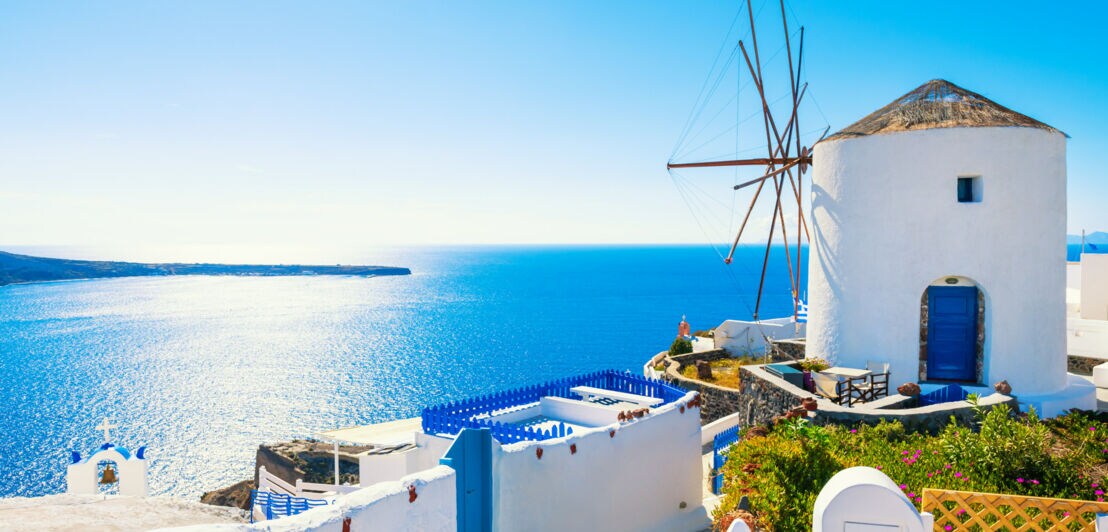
[923, 489, 1108, 532]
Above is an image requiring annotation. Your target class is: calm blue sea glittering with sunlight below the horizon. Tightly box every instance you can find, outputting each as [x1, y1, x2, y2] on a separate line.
[0, 246, 807, 497]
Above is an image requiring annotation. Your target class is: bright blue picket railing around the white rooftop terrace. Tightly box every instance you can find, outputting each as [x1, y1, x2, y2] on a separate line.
[422, 369, 686, 443]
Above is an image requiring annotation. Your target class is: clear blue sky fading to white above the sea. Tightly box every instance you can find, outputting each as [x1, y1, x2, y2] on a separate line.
[0, 0, 1108, 256]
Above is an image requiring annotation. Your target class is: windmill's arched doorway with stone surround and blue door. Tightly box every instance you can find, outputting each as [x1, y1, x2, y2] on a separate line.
[920, 276, 985, 382]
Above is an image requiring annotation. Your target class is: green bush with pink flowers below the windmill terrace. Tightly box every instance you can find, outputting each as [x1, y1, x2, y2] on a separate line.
[715, 406, 1108, 531]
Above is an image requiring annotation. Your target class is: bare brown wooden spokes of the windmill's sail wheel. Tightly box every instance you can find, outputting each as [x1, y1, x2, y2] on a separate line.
[666, 0, 827, 320]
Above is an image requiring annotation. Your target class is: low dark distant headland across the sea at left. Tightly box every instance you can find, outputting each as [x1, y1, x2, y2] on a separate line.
[0, 252, 411, 286]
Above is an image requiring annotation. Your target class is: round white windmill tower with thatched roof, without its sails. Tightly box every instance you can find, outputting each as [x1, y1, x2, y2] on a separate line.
[807, 80, 1095, 413]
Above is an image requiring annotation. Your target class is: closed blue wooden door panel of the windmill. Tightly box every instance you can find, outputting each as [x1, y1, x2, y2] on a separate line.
[927, 286, 977, 381]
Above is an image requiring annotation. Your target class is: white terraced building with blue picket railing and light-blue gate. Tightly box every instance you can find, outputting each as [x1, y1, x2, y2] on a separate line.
[172, 370, 711, 532]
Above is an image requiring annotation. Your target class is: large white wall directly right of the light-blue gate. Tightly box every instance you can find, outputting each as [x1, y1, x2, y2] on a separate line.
[493, 393, 710, 532]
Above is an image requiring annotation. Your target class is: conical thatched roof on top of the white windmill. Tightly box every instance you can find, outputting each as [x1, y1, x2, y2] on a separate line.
[825, 80, 1060, 141]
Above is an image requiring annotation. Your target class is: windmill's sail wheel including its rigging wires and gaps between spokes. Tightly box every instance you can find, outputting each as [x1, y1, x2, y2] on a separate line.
[666, 0, 830, 321]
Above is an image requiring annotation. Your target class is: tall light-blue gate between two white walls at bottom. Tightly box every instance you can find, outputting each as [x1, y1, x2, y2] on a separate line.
[439, 429, 492, 532]
